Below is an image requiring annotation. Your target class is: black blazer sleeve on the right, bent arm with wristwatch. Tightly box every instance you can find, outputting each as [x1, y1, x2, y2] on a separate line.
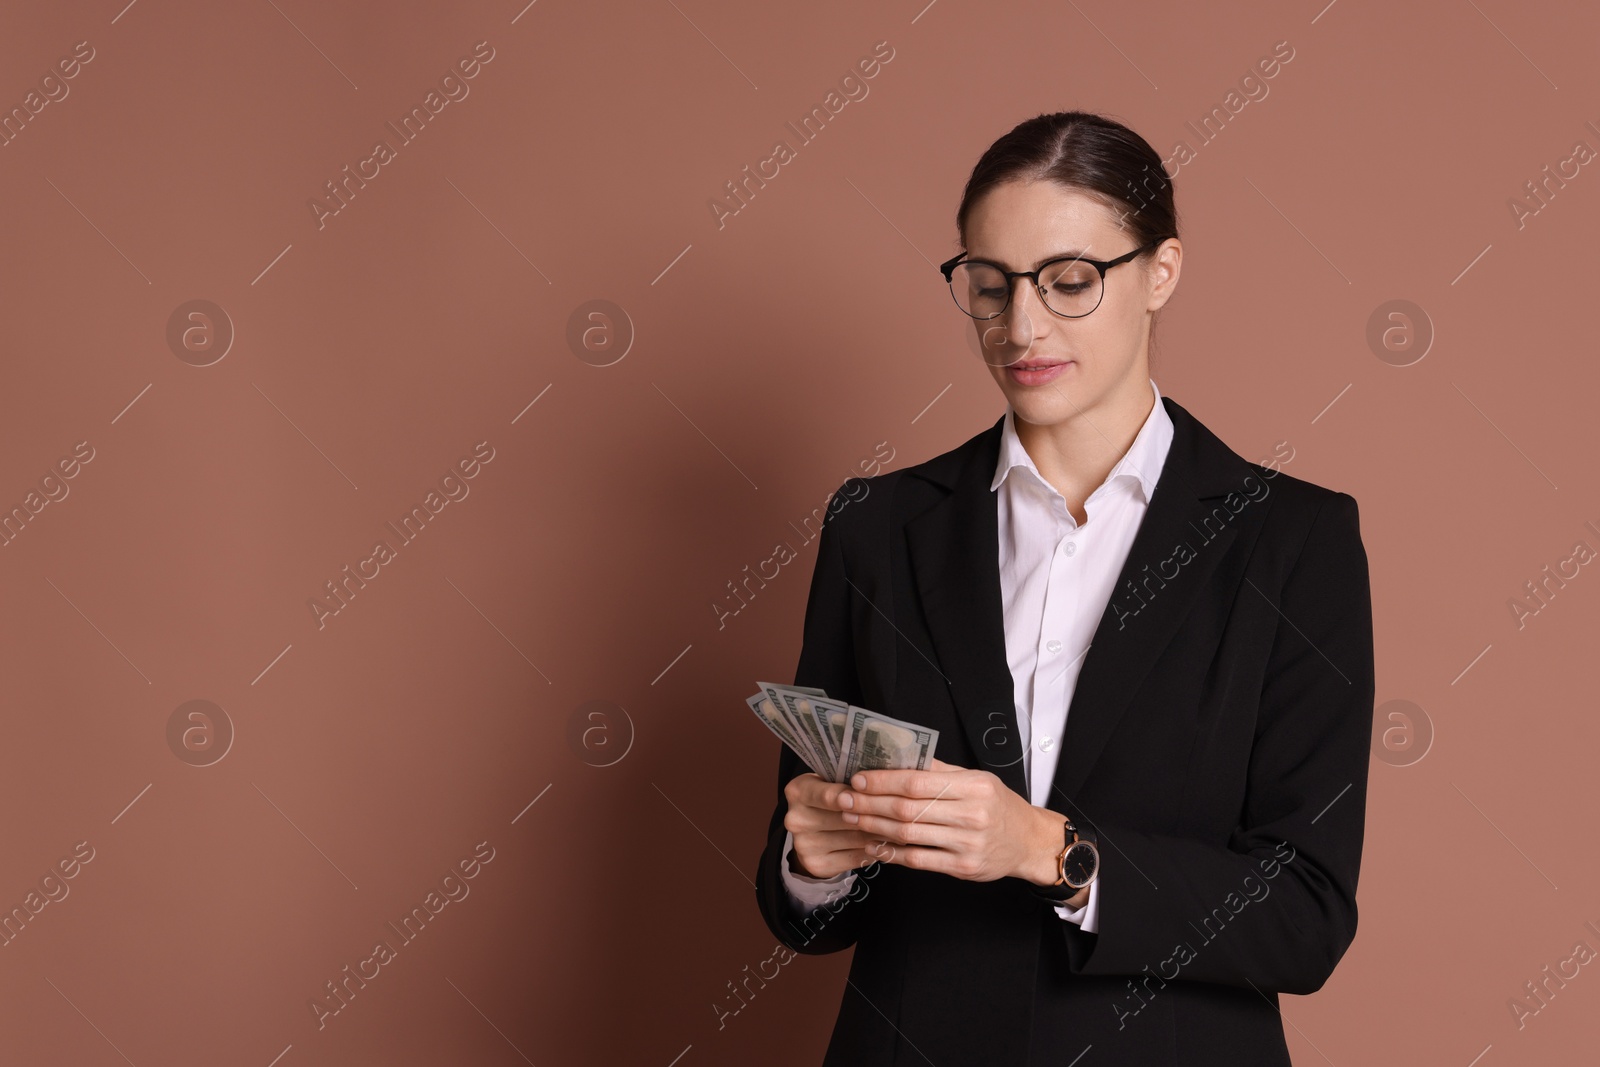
[1059, 493, 1374, 993]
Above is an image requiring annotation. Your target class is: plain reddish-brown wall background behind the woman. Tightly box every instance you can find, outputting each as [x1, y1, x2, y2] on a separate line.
[0, 0, 1600, 1067]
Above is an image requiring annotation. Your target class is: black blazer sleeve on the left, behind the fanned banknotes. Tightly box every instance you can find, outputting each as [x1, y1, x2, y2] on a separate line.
[755, 483, 869, 955]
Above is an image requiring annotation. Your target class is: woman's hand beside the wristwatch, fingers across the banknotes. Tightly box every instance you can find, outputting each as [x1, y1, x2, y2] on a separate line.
[838, 760, 1064, 885]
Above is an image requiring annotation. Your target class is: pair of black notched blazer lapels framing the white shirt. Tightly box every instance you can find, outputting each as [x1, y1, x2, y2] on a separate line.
[906, 397, 1251, 803]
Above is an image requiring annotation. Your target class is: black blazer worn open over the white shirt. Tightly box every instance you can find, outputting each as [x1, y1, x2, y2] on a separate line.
[757, 397, 1373, 1067]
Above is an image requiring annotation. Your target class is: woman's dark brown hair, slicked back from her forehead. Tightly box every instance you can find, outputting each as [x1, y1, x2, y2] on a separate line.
[955, 110, 1178, 254]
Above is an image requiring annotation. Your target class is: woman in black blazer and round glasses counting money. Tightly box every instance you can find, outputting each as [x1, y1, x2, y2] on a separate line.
[757, 112, 1373, 1067]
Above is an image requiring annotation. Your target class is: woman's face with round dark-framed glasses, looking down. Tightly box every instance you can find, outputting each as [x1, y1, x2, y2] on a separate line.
[966, 181, 1182, 426]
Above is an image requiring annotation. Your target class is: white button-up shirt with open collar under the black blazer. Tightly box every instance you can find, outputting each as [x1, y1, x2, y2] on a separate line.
[779, 379, 1173, 933]
